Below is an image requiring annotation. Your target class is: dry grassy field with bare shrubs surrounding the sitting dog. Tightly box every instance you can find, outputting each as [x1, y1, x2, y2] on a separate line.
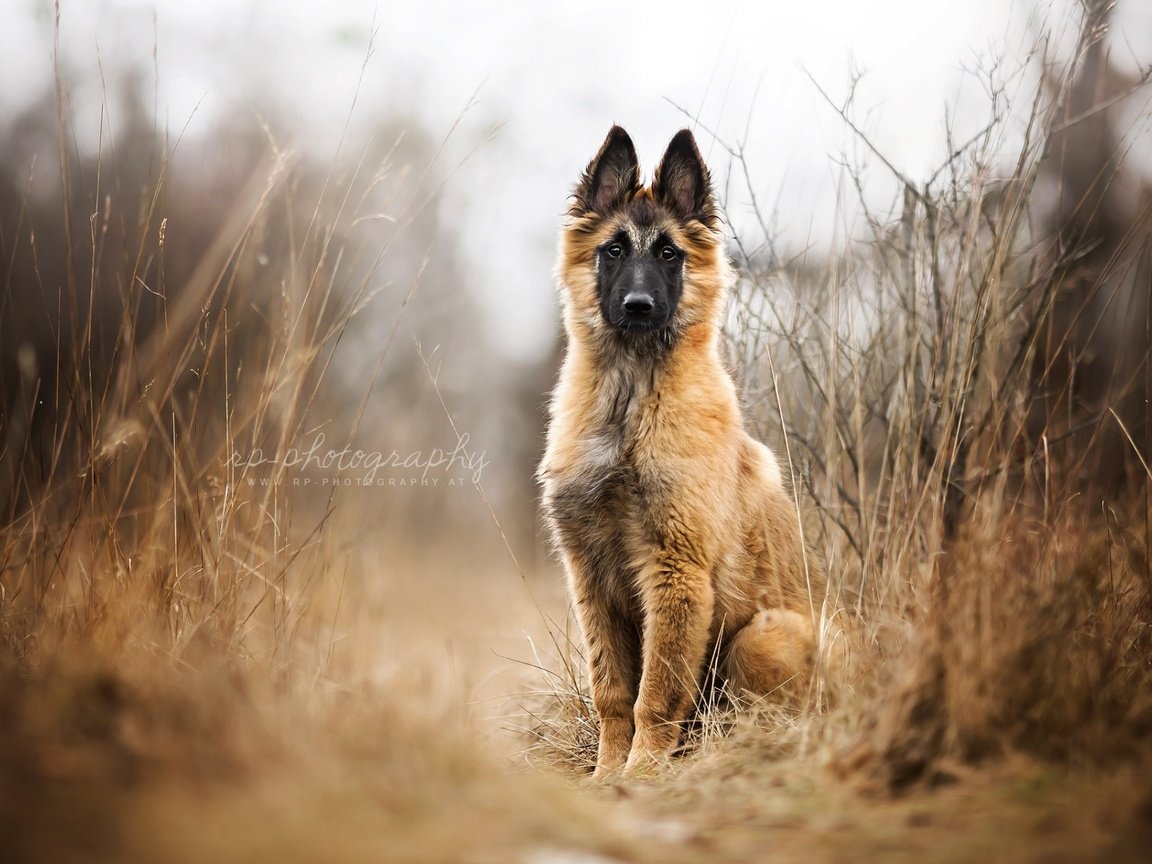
[0, 3, 1152, 864]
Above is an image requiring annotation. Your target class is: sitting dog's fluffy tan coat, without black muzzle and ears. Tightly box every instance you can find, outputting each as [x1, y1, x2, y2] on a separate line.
[539, 128, 821, 774]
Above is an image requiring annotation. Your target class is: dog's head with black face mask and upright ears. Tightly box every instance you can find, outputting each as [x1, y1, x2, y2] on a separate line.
[558, 126, 728, 351]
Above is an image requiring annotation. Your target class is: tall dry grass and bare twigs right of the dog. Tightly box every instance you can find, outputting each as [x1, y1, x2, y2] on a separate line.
[709, 3, 1152, 789]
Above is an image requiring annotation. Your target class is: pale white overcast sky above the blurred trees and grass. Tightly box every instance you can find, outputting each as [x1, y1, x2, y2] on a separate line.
[0, 0, 1152, 356]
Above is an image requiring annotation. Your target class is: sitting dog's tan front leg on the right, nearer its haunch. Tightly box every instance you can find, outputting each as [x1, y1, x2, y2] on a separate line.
[626, 556, 713, 771]
